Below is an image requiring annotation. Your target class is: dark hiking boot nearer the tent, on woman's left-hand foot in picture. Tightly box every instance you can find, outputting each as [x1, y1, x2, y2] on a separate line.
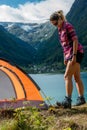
[56, 96, 72, 109]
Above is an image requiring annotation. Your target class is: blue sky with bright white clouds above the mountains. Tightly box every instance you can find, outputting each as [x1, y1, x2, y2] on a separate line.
[0, 0, 75, 23]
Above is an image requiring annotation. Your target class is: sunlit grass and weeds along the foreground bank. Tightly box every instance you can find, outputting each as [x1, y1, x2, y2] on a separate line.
[0, 104, 87, 130]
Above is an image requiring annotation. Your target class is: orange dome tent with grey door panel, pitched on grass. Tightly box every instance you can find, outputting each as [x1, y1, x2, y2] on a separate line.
[0, 59, 47, 108]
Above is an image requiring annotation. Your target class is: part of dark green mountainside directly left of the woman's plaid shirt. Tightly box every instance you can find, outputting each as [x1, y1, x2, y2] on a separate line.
[37, 29, 63, 68]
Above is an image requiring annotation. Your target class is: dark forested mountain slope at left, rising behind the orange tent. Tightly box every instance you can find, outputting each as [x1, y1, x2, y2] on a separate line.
[0, 25, 35, 66]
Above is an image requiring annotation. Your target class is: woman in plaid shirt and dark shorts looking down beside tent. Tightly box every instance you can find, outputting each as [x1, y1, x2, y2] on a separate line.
[50, 10, 85, 108]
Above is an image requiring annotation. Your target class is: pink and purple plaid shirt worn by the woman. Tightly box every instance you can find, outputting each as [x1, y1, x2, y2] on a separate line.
[58, 22, 83, 60]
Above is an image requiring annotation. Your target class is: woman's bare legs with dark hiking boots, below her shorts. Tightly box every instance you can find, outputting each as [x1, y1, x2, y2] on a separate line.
[62, 61, 85, 108]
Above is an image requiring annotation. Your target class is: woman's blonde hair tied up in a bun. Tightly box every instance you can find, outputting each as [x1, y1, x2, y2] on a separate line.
[50, 10, 67, 21]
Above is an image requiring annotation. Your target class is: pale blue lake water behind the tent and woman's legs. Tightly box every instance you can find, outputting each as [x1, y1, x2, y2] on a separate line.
[30, 72, 87, 104]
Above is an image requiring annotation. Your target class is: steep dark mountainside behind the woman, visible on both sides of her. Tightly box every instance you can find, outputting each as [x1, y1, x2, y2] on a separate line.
[36, 0, 87, 68]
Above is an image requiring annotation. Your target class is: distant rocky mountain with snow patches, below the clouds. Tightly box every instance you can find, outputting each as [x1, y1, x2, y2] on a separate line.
[0, 22, 55, 49]
